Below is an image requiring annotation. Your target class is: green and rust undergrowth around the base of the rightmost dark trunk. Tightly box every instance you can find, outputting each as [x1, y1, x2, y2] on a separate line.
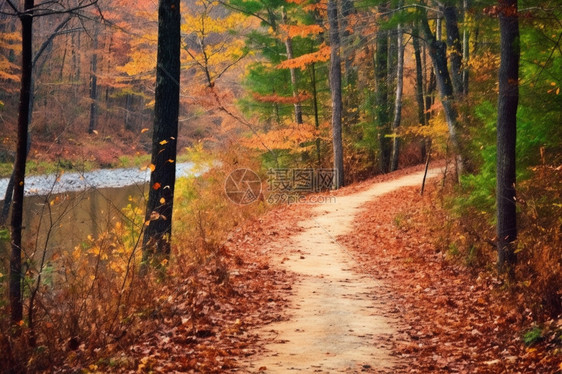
[427, 165, 562, 323]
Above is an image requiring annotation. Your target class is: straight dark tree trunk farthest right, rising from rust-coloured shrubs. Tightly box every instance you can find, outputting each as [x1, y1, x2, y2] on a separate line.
[496, 0, 520, 274]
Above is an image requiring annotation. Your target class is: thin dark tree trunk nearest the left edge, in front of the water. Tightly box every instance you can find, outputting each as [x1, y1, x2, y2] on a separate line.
[10, 0, 34, 324]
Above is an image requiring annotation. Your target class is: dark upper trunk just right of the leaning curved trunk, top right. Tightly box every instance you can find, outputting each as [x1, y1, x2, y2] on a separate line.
[443, 5, 464, 96]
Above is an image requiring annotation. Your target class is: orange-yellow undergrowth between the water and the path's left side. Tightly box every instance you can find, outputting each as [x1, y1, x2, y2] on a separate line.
[0, 147, 267, 373]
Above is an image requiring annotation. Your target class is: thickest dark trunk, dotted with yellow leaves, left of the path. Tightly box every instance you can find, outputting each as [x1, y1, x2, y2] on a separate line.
[143, 0, 181, 258]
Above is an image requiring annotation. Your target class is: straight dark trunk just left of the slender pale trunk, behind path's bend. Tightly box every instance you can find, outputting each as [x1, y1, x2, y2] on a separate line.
[375, 4, 391, 173]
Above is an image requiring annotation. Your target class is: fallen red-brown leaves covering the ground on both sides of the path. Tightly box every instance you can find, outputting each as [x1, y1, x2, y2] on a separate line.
[104, 167, 562, 373]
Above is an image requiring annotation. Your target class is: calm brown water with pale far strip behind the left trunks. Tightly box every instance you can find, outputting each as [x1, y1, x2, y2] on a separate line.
[0, 163, 197, 255]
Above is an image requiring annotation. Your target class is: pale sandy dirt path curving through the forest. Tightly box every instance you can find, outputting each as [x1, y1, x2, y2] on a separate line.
[245, 169, 440, 373]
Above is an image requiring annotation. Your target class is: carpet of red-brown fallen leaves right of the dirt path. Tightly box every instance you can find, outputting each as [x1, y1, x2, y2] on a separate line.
[339, 182, 562, 373]
